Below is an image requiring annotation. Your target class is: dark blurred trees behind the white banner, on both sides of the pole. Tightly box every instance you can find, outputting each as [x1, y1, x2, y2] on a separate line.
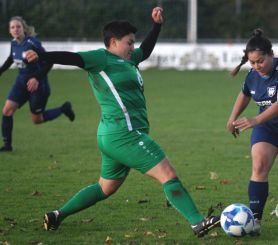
[0, 0, 278, 42]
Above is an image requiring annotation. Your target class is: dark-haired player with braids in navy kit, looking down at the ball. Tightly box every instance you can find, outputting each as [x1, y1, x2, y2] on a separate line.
[227, 29, 278, 235]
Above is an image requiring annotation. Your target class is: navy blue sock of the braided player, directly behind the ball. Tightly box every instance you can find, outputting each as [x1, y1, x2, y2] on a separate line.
[248, 180, 268, 220]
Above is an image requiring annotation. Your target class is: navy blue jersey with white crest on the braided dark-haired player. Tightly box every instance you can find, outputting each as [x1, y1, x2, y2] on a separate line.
[242, 58, 278, 126]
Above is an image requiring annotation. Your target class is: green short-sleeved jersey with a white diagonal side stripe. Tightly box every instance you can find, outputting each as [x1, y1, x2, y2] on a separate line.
[79, 48, 149, 135]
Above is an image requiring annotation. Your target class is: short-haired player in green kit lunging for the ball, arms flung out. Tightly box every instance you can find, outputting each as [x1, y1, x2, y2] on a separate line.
[26, 7, 219, 237]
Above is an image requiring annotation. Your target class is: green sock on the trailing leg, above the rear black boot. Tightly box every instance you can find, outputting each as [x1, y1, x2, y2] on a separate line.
[58, 183, 108, 221]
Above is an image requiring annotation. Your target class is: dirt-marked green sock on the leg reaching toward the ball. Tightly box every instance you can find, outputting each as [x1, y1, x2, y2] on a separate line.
[163, 178, 204, 225]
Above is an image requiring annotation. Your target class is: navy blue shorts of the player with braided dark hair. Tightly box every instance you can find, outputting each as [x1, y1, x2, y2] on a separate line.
[250, 123, 278, 148]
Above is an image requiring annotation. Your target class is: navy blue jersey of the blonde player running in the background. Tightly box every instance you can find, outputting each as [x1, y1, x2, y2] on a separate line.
[11, 36, 45, 76]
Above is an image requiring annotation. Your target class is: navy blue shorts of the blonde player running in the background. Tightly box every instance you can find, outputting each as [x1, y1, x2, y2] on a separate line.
[8, 75, 50, 114]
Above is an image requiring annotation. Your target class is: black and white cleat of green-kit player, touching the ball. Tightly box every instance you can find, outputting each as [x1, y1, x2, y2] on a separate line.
[191, 216, 220, 237]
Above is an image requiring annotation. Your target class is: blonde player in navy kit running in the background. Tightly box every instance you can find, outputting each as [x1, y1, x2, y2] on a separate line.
[0, 16, 75, 152]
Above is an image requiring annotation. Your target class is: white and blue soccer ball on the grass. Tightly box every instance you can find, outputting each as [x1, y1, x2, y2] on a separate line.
[220, 203, 254, 237]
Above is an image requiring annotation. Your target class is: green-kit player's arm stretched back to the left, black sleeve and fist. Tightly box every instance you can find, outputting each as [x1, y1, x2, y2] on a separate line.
[26, 50, 84, 68]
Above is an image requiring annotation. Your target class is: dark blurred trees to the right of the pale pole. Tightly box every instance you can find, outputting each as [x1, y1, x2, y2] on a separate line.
[198, 0, 278, 42]
